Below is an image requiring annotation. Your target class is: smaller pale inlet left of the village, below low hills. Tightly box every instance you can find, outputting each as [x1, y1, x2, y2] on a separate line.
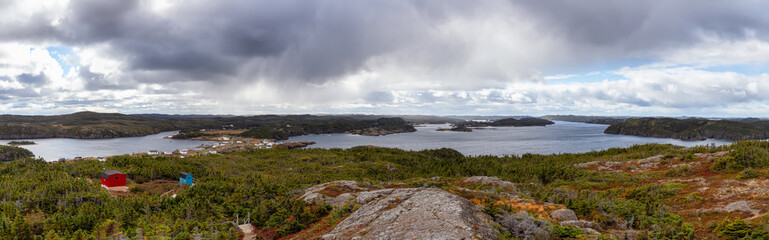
[0, 132, 211, 161]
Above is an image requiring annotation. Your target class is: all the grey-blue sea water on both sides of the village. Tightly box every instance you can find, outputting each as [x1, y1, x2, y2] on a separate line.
[0, 121, 731, 161]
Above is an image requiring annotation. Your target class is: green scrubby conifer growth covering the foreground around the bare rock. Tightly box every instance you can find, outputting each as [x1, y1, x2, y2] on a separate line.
[0, 141, 769, 239]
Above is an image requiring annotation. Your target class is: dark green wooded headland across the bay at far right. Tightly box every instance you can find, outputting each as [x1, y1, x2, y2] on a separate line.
[604, 118, 769, 140]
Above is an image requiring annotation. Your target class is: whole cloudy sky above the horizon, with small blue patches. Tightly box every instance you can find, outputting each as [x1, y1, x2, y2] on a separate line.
[0, 0, 769, 117]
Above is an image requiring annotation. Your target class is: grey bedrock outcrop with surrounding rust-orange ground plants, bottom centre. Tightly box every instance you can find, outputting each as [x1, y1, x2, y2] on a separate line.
[292, 176, 620, 239]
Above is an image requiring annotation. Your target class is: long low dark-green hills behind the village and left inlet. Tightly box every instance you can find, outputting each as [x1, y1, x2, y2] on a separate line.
[0, 112, 426, 139]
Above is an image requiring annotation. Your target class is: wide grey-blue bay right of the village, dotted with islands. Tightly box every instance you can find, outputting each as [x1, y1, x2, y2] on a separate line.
[280, 121, 731, 155]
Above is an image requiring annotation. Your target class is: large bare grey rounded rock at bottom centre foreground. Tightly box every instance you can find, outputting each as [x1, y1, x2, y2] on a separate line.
[323, 188, 499, 239]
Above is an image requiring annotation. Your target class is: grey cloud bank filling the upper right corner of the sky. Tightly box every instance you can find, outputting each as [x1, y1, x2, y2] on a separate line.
[511, 0, 769, 50]
